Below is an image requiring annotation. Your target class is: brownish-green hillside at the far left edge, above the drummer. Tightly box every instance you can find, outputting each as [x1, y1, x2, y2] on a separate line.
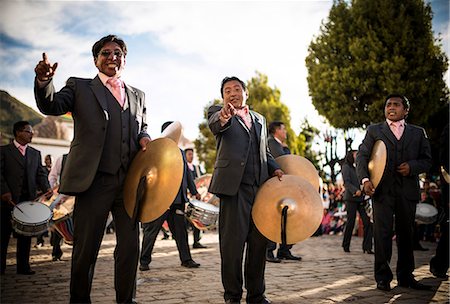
[0, 90, 44, 143]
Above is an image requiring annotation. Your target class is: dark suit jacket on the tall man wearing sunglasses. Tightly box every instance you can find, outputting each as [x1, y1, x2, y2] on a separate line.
[34, 76, 148, 194]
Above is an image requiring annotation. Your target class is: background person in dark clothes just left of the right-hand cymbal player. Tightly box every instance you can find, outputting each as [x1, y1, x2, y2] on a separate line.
[341, 150, 373, 254]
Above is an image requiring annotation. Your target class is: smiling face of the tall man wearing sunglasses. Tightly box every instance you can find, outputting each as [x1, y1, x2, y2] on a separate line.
[94, 42, 125, 77]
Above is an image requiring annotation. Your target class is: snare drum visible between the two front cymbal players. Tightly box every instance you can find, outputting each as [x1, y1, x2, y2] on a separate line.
[185, 200, 219, 230]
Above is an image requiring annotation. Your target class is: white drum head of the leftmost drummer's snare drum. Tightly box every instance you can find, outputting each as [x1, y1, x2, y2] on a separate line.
[12, 202, 52, 224]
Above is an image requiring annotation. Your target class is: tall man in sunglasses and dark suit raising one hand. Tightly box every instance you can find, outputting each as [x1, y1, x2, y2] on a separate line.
[35, 35, 150, 303]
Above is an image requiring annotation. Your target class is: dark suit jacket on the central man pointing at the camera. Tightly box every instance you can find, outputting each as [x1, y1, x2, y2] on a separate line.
[208, 106, 280, 195]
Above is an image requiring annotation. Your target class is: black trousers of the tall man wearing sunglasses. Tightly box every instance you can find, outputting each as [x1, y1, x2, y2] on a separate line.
[70, 169, 139, 303]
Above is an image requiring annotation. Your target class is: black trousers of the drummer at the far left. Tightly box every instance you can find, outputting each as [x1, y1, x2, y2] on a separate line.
[0, 202, 31, 273]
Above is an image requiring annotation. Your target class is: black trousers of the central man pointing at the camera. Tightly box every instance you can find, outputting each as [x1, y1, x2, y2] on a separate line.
[219, 184, 267, 303]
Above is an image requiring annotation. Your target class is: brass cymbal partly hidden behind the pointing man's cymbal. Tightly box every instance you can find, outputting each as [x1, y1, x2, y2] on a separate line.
[275, 154, 321, 192]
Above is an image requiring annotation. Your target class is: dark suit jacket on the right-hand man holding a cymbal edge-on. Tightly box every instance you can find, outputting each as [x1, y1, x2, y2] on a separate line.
[356, 122, 432, 201]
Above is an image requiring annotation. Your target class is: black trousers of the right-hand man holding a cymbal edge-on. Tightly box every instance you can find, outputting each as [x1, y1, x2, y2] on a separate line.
[373, 187, 417, 282]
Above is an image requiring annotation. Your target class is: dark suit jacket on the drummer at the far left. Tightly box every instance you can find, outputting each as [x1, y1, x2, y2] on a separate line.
[0, 143, 50, 203]
